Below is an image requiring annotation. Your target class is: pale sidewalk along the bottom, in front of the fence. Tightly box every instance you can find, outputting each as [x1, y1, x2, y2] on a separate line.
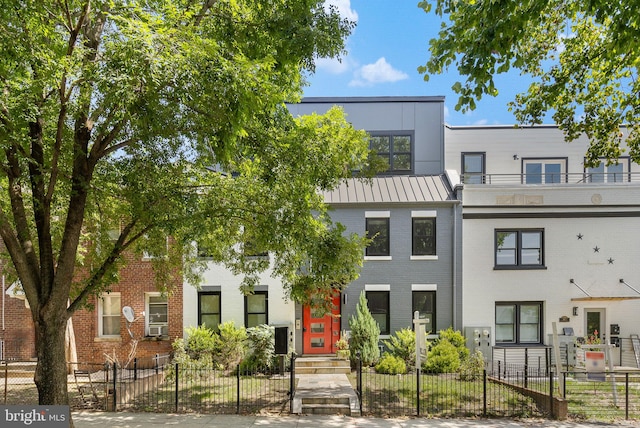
[73, 412, 638, 428]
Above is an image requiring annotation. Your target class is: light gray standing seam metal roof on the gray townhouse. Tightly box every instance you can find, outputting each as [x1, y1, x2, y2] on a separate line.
[323, 174, 456, 204]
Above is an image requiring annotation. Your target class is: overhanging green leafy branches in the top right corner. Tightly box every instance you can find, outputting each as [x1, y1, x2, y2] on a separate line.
[419, 0, 640, 166]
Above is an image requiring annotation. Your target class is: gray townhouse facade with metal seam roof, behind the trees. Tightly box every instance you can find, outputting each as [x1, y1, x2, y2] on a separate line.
[289, 97, 462, 334]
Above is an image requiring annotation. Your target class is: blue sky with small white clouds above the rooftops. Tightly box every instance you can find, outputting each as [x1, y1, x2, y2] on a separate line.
[304, 0, 528, 125]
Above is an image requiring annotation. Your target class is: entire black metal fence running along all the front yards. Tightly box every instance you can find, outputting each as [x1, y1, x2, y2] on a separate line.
[0, 356, 640, 422]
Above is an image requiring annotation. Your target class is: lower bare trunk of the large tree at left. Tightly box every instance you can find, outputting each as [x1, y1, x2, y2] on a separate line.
[35, 311, 69, 405]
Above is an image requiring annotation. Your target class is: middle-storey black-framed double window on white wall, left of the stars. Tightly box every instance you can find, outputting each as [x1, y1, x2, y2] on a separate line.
[495, 229, 544, 269]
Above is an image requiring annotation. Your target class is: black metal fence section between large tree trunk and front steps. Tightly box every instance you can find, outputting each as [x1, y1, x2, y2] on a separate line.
[69, 356, 294, 413]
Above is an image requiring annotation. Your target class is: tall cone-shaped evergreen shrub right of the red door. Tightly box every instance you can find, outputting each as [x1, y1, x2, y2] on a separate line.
[349, 290, 380, 367]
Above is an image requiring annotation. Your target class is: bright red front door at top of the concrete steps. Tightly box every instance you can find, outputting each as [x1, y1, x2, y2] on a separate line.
[302, 294, 340, 354]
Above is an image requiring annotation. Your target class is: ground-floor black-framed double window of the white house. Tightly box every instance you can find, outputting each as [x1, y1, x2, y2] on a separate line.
[496, 302, 543, 345]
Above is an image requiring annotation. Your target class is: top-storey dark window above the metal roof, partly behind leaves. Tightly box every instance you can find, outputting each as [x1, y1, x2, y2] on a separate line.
[369, 131, 413, 174]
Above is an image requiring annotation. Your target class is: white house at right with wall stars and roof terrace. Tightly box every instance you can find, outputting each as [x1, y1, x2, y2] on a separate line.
[445, 126, 640, 365]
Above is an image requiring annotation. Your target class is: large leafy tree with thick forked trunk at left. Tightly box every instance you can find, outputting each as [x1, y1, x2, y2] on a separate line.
[0, 0, 376, 404]
